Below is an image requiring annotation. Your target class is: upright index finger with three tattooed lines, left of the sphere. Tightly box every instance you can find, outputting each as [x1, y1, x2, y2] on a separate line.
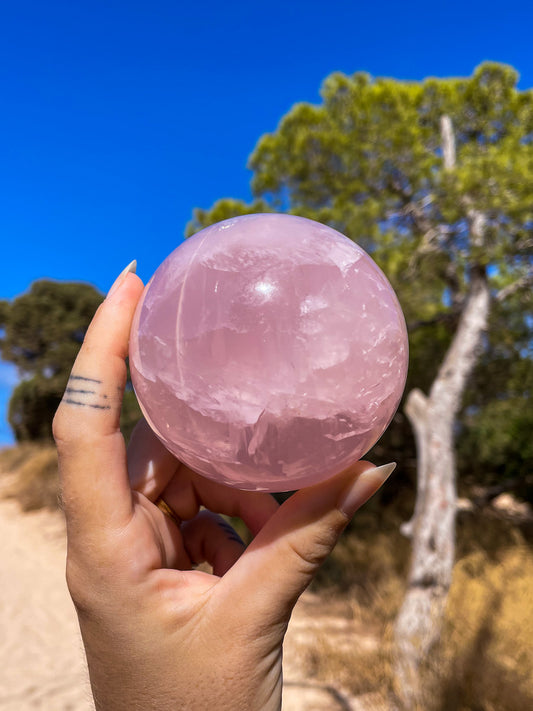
[54, 274, 143, 527]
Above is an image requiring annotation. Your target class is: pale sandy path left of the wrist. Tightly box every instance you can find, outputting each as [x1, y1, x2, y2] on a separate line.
[0, 501, 93, 711]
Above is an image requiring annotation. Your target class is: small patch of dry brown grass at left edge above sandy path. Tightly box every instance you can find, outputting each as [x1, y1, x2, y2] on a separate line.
[0, 444, 59, 511]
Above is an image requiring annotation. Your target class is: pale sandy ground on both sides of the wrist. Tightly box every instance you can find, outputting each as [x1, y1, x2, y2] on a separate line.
[0, 490, 378, 711]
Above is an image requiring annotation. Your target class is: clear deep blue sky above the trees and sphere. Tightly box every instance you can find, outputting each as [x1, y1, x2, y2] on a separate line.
[0, 0, 533, 443]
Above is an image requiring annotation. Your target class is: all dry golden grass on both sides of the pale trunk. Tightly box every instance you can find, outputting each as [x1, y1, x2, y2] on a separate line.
[305, 518, 533, 711]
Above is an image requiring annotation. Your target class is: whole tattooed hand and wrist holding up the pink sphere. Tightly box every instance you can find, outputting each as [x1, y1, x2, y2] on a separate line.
[54, 264, 392, 711]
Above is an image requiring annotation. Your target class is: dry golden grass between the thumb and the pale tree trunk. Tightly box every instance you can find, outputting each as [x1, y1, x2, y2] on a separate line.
[304, 513, 409, 709]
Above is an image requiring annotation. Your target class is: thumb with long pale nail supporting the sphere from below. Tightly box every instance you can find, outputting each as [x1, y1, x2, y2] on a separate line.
[217, 461, 396, 625]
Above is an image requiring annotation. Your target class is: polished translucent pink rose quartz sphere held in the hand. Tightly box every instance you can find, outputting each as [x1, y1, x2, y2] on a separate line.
[130, 214, 408, 491]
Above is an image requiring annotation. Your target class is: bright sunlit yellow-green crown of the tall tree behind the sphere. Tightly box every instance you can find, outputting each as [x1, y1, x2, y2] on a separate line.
[189, 63, 533, 326]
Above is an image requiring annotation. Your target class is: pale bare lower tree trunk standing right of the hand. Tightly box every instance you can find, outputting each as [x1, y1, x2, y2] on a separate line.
[394, 267, 490, 709]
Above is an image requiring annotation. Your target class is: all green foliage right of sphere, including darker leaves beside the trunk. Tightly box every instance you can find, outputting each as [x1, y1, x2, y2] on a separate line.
[189, 62, 533, 486]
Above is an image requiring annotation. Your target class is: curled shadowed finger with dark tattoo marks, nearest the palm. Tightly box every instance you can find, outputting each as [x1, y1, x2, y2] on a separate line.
[181, 511, 245, 577]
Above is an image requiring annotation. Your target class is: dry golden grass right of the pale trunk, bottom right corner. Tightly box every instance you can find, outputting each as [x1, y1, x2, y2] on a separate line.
[432, 542, 533, 711]
